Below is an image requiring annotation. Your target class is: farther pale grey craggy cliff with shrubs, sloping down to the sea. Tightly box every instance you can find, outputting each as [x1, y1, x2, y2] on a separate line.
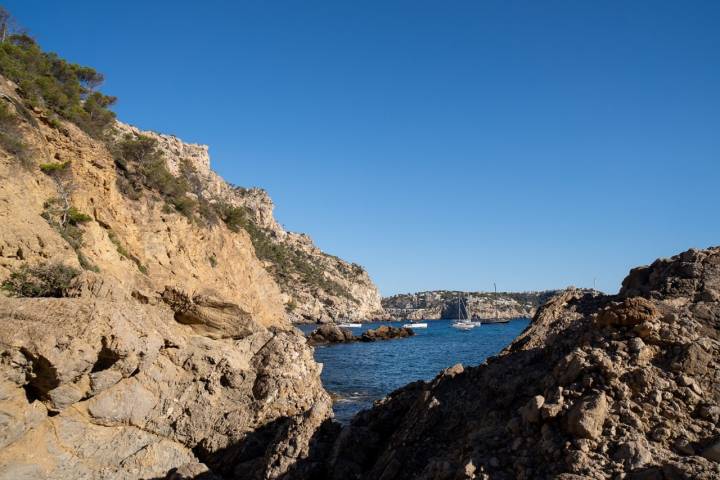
[109, 122, 382, 323]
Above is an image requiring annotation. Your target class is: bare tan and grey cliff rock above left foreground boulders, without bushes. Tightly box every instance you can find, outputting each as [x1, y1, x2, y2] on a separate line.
[0, 79, 382, 323]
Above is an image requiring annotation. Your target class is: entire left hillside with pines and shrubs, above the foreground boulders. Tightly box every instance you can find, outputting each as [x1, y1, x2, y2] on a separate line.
[0, 29, 382, 324]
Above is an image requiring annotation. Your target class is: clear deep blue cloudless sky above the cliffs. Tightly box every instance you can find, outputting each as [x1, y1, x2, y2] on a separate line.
[7, 0, 720, 294]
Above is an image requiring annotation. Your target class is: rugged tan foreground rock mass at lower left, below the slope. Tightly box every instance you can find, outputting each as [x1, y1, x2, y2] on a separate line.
[0, 298, 331, 479]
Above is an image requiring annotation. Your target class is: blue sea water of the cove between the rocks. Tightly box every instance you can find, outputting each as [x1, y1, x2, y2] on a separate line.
[299, 318, 529, 423]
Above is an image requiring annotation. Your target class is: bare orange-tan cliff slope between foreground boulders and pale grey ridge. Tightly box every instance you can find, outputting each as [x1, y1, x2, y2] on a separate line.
[0, 81, 287, 326]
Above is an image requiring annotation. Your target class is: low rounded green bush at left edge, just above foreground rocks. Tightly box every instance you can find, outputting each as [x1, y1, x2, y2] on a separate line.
[2, 263, 80, 297]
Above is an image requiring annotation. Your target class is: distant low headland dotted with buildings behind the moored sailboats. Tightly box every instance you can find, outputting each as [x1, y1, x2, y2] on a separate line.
[382, 290, 557, 320]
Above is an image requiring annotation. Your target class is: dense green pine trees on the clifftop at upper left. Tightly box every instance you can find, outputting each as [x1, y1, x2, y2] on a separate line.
[0, 9, 116, 138]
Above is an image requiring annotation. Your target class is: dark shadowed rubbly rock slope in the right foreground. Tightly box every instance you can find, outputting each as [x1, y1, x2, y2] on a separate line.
[295, 248, 720, 480]
